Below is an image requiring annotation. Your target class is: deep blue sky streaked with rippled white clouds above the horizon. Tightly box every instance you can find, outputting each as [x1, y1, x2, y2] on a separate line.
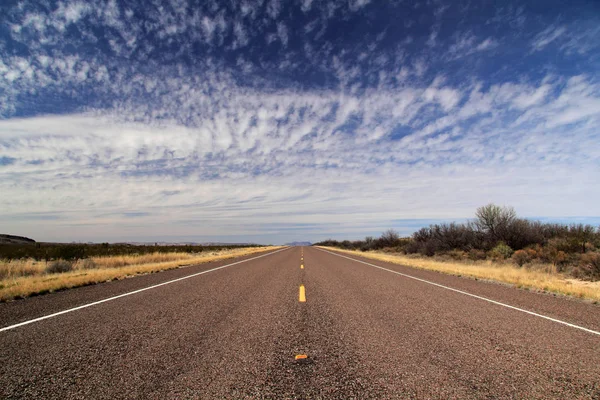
[0, 0, 600, 243]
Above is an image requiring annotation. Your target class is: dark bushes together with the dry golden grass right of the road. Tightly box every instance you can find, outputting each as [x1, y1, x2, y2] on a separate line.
[315, 204, 600, 300]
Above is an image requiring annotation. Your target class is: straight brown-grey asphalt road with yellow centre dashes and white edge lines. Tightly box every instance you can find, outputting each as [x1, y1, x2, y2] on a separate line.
[0, 247, 600, 399]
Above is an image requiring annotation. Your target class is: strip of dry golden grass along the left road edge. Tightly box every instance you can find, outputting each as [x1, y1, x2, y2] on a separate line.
[0, 246, 279, 301]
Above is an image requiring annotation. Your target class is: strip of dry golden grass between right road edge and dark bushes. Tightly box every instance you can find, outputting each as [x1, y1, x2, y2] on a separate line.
[322, 248, 600, 301]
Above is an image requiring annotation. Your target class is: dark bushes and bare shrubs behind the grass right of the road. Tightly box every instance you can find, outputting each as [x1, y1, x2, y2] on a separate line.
[315, 204, 600, 280]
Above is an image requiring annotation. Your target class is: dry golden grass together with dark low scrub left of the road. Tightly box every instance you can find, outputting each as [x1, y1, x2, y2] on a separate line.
[0, 244, 276, 301]
